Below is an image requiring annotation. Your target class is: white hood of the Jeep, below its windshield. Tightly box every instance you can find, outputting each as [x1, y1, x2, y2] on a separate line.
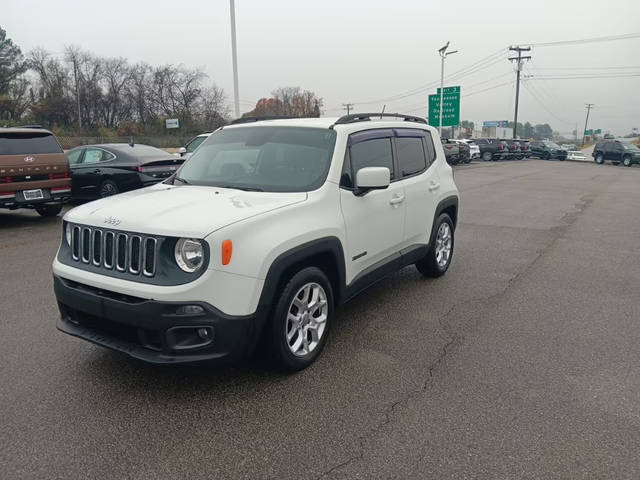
[65, 184, 307, 238]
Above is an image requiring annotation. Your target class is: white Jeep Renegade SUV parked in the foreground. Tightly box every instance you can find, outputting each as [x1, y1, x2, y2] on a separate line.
[53, 114, 459, 370]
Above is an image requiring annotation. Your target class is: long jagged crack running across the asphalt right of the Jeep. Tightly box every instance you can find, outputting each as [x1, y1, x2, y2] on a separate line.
[316, 192, 601, 480]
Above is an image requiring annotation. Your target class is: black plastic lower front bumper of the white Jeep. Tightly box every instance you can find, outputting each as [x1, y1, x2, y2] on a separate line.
[54, 275, 265, 364]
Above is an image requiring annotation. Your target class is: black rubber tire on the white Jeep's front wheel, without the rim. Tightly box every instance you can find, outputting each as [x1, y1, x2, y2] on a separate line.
[267, 267, 334, 372]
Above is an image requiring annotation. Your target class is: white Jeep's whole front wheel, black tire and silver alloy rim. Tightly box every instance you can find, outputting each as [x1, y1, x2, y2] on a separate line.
[270, 267, 334, 372]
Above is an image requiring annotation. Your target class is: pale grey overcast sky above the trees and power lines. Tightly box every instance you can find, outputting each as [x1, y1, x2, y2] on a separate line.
[5, 0, 640, 134]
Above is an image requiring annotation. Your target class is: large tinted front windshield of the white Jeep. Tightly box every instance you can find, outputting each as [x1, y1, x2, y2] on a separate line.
[177, 126, 336, 192]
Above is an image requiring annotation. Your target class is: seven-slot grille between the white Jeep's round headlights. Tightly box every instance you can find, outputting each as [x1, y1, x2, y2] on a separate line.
[71, 225, 158, 277]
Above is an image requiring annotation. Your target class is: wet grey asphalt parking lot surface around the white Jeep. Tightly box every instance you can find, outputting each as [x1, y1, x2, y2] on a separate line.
[0, 160, 640, 479]
